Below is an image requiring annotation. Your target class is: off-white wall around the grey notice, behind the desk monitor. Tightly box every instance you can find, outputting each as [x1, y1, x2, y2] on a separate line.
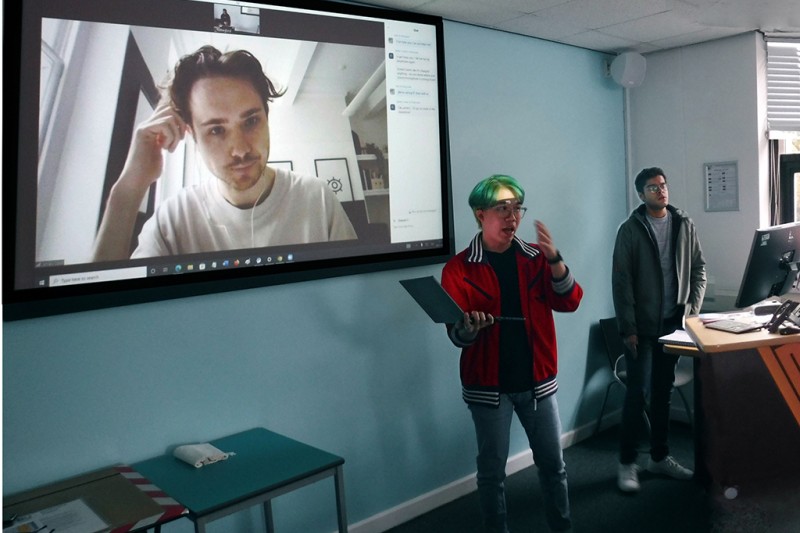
[628, 32, 768, 309]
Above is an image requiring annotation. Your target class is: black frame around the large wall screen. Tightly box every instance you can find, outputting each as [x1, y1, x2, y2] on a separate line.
[3, 0, 454, 321]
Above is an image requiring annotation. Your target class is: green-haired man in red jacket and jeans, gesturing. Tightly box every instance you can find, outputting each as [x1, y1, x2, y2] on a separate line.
[442, 175, 583, 533]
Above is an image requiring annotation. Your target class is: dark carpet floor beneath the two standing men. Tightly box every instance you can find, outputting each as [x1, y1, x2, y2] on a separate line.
[390, 423, 800, 533]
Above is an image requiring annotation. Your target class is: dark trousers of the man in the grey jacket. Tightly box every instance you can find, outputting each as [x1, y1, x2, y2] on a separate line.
[619, 316, 681, 465]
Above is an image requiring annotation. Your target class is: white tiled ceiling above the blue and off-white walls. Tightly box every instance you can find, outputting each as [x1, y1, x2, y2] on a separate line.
[365, 0, 800, 54]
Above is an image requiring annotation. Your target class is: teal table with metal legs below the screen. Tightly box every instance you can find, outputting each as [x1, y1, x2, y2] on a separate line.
[131, 428, 347, 533]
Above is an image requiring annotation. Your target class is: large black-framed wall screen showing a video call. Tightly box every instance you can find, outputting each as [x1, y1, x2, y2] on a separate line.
[3, 0, 454, 320]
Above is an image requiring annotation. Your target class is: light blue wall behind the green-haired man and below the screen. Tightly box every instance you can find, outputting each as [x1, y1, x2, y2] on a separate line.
[3, 19, 626, 533]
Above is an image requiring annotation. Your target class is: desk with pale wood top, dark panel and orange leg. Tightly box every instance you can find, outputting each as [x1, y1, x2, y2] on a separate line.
[673, 317, 800, 494]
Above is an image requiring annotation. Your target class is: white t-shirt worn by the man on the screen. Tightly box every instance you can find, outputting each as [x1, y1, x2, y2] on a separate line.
[132, 168, 356, 258]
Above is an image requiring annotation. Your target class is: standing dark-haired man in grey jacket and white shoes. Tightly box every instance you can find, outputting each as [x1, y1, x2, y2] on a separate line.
[611, 167, 706, 492]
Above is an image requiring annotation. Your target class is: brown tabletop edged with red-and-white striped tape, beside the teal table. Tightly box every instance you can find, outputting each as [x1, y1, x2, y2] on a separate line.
[3, 465, 186, 533]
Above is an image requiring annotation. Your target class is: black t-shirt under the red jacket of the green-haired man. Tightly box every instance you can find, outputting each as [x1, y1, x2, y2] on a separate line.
[486, 246, 533, 392]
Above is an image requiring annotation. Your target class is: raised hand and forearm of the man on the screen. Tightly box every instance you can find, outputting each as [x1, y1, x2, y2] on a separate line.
[92, 101, 187, 261]
